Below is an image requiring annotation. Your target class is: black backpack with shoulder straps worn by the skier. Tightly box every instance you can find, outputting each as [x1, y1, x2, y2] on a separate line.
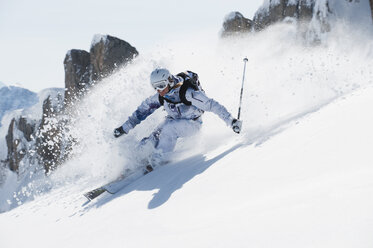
[159, 71, 203, 106]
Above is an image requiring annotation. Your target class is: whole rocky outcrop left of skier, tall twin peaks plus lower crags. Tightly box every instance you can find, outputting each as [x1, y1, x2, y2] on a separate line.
[2, 35, 138, 176]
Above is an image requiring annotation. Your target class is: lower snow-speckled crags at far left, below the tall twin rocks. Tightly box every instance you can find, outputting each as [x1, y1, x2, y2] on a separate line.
[5, 91, 63, 173]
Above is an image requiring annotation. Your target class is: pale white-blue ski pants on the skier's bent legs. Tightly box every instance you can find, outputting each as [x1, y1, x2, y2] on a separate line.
[139, 118, 202, 166]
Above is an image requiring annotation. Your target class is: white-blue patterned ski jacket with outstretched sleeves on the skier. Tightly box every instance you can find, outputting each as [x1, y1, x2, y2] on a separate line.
[122, 73, 233, 133]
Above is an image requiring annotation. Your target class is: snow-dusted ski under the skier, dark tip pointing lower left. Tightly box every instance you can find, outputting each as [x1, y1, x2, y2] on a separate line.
[83, 165, 153, 201]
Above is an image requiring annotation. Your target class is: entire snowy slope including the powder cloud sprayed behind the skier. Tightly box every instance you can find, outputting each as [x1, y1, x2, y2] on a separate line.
[0, 1, 373, 248]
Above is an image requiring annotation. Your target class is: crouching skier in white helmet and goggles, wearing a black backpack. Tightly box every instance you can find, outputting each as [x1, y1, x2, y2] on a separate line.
[114, 68, 242, 172]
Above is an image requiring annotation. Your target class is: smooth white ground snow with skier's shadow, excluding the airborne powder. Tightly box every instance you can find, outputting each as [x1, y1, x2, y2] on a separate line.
[0, 76, 373, 248]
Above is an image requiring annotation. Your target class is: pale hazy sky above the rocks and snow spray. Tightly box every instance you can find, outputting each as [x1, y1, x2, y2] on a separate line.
[0, 0, 263, 92]
